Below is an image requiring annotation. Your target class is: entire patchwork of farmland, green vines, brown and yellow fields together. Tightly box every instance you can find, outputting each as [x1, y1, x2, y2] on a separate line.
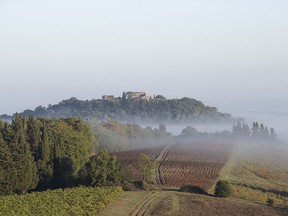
[0, 138, 288, 216]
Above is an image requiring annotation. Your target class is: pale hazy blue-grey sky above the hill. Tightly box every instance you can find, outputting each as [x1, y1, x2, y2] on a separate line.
[0, 0, 288, 114]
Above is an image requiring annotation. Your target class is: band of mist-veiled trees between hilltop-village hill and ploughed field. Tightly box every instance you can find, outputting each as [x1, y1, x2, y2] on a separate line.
[91, 117, 282, 152]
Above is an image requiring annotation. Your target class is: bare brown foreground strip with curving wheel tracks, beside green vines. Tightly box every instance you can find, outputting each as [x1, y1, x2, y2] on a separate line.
[100, 190, 288, 216]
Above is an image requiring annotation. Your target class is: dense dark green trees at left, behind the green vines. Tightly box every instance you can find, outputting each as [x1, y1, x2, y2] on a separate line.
[0, 114, 121, 195]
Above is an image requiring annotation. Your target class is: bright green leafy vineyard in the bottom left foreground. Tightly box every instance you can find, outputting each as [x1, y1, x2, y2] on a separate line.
[0, 187, 122, 216]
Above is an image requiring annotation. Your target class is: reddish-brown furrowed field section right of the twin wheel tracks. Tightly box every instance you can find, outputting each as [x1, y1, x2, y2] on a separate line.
[160, 143, 233, 191]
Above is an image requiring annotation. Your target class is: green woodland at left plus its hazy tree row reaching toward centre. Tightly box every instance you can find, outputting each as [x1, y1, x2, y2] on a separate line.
[0, 114, 172, 195]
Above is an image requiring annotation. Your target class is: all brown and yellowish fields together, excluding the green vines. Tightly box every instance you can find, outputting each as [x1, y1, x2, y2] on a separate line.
[109, 142, 288, 216]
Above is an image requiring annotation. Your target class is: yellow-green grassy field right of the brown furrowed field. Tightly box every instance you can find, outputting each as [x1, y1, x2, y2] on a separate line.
[220, 143, 288, 206]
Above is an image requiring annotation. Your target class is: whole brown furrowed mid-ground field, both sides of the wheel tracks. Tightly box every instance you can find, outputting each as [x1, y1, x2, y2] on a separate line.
[116, 143, 233, 190]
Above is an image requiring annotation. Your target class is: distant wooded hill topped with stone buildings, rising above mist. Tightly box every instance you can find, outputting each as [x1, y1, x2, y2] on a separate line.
[1, 92, 233, 123]
